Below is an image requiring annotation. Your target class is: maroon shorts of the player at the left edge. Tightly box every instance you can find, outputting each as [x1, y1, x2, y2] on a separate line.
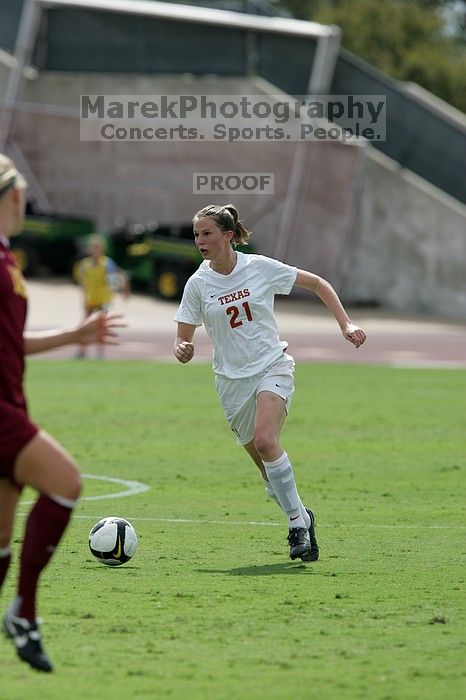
[0, 399, 39, 479]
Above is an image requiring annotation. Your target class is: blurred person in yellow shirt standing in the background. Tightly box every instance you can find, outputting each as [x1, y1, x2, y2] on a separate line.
[74, 236, 130, 358]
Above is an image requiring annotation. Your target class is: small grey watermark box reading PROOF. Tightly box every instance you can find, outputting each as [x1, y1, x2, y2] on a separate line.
[193, 173, 275, 194]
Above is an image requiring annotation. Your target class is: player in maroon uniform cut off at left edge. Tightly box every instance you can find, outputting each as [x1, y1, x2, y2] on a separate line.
[0, 154, 123, 671]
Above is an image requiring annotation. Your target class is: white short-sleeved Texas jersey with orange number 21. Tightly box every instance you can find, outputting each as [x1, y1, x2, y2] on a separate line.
[175, 252, 298, 379]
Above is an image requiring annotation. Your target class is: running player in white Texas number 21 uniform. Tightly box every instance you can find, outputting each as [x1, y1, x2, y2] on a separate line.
[174, 204, 366, 561]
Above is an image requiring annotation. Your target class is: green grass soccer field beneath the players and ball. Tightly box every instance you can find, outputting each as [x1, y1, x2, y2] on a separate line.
[0, 360, 466, 700]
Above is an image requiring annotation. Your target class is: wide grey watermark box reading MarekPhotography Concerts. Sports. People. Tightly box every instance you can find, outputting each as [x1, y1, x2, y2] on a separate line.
[80, 95, 387, 143]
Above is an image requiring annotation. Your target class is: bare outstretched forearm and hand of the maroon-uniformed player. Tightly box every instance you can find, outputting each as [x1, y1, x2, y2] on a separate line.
[23, 312, 126, 355]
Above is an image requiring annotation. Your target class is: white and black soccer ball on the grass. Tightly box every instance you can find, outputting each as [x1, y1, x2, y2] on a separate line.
[89, 517, 138, 566]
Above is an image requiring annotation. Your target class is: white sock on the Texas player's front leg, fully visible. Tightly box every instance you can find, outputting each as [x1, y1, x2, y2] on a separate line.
[263, 452, 309, 529]
